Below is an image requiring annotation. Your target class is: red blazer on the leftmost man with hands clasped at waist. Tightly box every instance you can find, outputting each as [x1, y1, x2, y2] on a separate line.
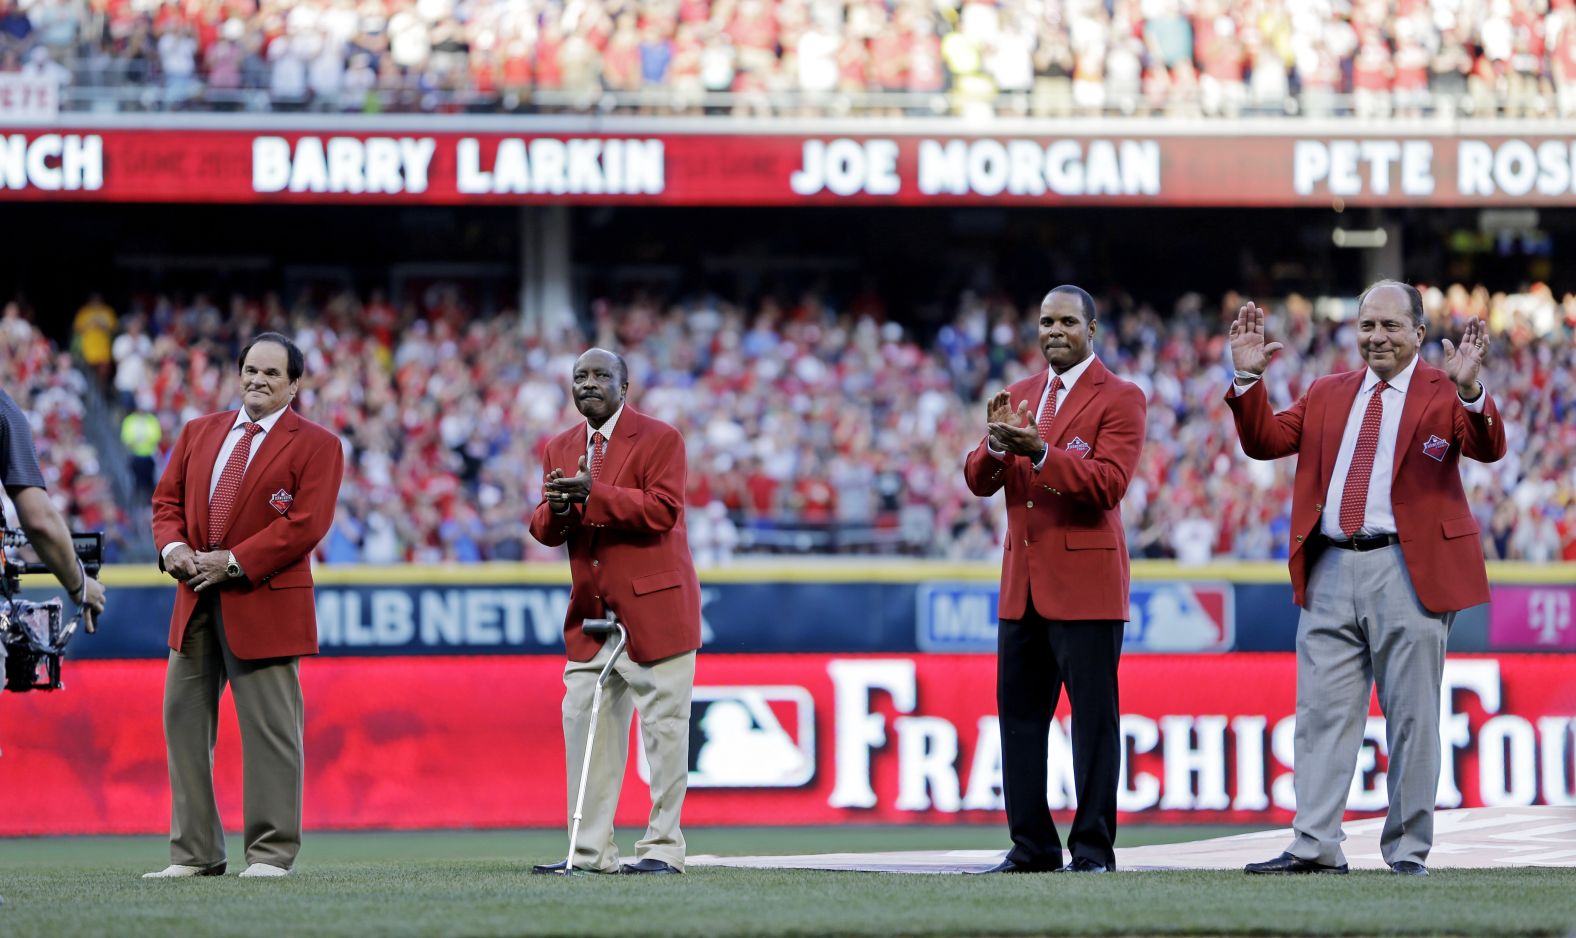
[153, 410, 345, 659]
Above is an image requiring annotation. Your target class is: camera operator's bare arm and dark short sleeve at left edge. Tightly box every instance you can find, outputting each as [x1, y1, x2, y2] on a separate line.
[0, 389, 104, 640]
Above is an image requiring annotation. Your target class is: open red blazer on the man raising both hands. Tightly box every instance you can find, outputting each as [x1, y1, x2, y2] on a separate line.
[1226, 361, 1505, 613]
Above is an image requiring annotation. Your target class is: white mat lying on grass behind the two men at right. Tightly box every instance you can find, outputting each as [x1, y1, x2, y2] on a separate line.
[689, 807, 1576, 873]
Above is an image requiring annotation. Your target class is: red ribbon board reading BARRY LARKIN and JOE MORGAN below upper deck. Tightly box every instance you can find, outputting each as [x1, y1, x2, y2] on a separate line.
[0, 128, 1576, 207]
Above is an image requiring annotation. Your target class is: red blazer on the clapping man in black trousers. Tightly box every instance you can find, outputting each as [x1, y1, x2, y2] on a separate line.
[963, 358, 1147, 621]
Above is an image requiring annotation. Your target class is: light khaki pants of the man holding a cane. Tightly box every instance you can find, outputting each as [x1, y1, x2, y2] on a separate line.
[564, 640, 695, 872]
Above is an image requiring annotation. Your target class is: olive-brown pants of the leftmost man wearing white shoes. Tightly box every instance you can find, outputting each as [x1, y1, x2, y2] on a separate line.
[164, 593, 306, 870]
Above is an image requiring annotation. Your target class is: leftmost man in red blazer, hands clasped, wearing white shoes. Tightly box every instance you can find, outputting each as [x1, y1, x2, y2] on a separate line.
[143, 333, 345, 878]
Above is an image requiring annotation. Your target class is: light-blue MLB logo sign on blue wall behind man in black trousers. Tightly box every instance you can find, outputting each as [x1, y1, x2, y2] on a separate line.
[916, 582, 1237, 653]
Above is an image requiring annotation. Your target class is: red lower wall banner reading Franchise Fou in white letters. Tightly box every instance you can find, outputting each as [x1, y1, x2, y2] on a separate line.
[0, 653, 1576, 836]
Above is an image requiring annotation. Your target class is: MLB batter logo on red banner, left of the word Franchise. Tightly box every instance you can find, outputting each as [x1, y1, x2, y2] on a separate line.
[638, 686, 815, 788]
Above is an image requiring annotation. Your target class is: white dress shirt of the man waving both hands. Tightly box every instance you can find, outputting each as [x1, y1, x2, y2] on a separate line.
[1232, 356, 1488, 541]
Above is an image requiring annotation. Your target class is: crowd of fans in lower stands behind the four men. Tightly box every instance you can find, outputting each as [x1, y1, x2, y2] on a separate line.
[46, 275, 1576, 563]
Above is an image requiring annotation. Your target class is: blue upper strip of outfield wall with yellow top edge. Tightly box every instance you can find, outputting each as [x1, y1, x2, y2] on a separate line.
[55, 561, 1576, 659]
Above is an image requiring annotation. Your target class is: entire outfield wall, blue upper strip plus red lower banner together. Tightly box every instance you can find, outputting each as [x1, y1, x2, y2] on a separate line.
[0, 564, 1576, 836]
